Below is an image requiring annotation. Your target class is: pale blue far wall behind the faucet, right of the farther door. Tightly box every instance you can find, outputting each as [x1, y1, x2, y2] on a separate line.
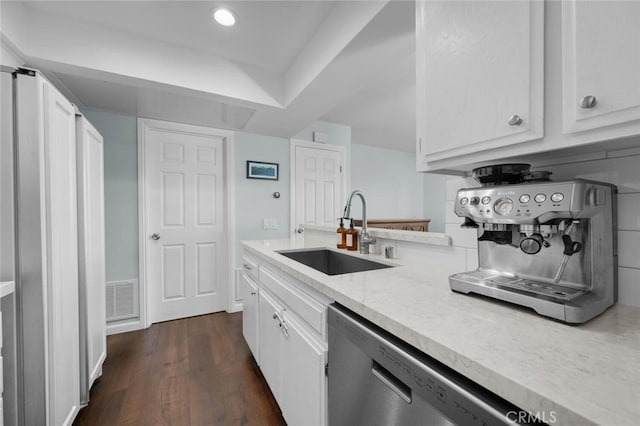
[351, 144, 424, 219]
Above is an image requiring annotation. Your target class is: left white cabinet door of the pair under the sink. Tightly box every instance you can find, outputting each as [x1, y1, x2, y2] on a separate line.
[258, 291, 288, 404]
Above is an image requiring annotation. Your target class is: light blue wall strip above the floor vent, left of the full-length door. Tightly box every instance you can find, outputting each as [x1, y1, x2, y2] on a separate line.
[81, 107, 138, 281]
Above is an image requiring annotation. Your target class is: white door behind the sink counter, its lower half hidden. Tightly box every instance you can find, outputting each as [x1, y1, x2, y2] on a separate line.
[291, 141, 345, 230]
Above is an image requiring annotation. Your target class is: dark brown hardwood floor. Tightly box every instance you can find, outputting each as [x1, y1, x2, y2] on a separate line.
[74, 312, 285, 426]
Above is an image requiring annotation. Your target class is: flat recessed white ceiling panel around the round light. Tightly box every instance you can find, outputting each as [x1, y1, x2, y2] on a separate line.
[23, 0, 335, 72]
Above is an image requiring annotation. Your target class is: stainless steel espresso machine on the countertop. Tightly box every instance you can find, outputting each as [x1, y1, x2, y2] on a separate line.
[449, 164, 617, 324]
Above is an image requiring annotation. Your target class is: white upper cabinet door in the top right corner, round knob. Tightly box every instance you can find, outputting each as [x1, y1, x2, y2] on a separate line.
[562, 1, 640, 133]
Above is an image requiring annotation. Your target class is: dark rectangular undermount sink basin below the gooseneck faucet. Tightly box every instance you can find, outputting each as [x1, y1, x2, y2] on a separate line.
[277, 249, 393, 275]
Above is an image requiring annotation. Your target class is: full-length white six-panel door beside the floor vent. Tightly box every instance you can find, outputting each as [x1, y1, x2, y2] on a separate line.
[141, 120, 229, 323]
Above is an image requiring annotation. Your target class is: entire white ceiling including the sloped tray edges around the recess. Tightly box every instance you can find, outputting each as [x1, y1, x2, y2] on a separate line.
[0, 0, 415, 152]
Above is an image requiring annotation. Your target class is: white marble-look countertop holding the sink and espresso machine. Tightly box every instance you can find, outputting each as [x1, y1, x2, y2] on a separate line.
[243, 238, 640, 426]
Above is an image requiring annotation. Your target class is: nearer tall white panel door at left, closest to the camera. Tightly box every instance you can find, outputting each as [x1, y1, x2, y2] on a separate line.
[42, 77, 80, 425]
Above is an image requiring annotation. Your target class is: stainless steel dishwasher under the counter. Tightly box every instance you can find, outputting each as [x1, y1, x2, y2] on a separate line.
[328, 304, 532, 426]
